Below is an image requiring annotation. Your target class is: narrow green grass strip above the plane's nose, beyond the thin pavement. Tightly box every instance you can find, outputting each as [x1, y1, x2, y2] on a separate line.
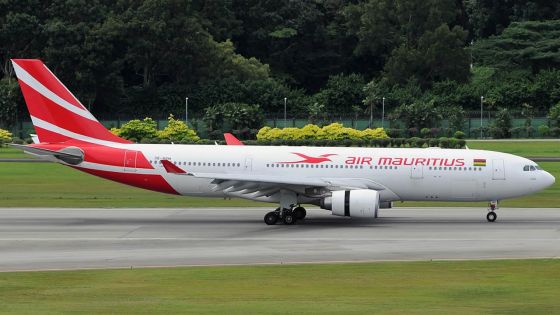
[467, 140, 560, 157]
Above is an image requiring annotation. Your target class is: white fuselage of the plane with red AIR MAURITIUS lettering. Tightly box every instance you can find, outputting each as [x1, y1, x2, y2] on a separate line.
[119, 144, 554, 202]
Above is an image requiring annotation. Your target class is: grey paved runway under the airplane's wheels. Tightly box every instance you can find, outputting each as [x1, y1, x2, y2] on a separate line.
[0, 208, 560, 271]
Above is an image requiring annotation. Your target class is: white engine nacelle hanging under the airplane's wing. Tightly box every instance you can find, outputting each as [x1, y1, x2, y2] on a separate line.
[321, 189, 379, 218]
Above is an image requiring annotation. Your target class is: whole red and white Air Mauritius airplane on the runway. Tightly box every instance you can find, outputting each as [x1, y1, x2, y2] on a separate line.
[8, 59, 555, 225]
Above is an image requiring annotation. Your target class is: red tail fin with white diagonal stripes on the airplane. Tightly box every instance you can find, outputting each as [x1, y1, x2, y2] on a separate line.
[12, 59, 129, 143]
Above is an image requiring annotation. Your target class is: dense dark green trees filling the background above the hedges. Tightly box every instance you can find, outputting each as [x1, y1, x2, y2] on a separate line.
[0, 0, 560, 135]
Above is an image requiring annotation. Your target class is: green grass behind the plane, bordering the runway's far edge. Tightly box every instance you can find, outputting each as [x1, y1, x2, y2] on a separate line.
[0, 162, 560, 208]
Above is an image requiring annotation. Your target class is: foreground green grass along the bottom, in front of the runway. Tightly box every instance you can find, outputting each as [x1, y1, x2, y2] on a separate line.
[0, 260, 560, 315]
